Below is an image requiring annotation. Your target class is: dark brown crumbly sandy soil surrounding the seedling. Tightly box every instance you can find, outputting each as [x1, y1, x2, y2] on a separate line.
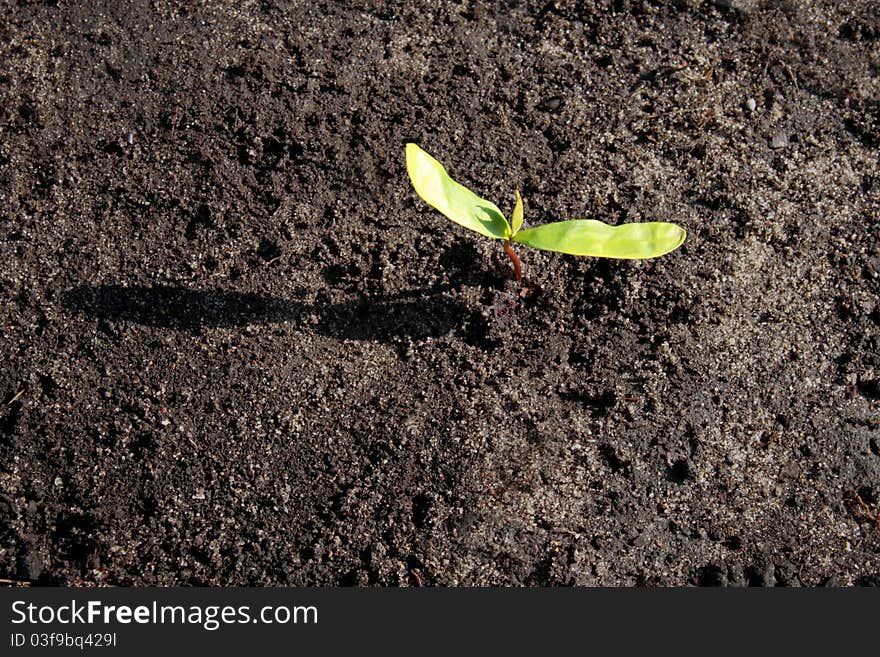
[0, 0, 880, 586]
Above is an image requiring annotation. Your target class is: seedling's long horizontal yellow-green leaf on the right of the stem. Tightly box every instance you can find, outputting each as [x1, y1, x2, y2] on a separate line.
[513, 219, 686, 259]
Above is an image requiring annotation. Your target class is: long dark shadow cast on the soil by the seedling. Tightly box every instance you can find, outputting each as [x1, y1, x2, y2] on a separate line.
[63, 285, 467, 341]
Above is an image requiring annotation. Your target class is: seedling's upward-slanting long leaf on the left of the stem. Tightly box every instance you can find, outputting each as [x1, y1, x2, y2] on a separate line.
[406, 144, 510, 240]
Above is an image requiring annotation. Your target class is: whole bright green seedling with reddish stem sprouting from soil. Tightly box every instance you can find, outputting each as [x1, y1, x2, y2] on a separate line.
[406, 144, 686, 281]
